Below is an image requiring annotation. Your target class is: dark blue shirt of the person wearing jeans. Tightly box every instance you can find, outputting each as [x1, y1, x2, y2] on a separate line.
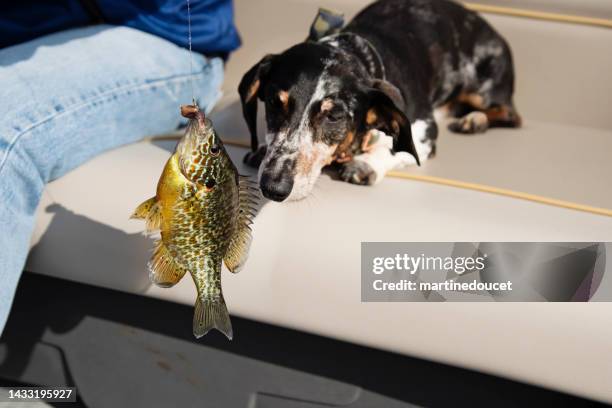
[0, 0, 240, 54]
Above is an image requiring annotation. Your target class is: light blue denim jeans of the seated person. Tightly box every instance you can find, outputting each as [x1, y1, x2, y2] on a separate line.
[0, 25, 223, 333]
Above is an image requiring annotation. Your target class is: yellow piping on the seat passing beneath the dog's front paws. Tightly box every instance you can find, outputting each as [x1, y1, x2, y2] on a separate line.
[154, 135, 612, 217]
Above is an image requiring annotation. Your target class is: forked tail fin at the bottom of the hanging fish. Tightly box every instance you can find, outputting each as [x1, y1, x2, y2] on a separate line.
[193, 296, 234, 340]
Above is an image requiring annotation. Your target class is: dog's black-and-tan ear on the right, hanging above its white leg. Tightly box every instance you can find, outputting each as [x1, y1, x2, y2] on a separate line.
[364, 87, 421, 166]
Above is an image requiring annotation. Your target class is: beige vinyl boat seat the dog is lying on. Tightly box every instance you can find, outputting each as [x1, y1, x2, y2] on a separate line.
[26, 0, 612, 402]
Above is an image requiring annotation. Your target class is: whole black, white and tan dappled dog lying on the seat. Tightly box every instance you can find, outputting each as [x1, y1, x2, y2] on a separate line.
[239, 0, 521, 201]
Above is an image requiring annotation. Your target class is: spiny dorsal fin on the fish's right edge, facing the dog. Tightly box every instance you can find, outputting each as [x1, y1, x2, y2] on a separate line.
[223, 176, 259, 273]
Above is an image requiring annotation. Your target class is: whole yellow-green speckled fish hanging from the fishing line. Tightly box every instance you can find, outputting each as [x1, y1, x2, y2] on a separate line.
[132, 105, 259, 340]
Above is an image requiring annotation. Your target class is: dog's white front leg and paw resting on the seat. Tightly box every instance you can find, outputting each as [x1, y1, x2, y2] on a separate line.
[340, 130, 416, 185]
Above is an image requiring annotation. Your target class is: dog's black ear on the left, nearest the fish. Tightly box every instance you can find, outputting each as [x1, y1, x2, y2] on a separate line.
[238, 54, 274, 151]
